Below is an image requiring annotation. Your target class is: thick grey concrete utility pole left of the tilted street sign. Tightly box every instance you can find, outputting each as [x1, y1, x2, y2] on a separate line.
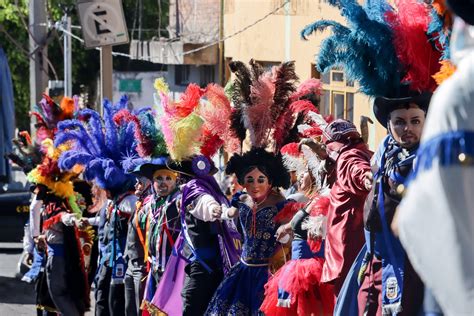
[28, 0, 48, 134]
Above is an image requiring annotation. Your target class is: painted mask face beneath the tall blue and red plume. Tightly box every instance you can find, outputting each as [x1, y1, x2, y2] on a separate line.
[388, 104, 425, 149]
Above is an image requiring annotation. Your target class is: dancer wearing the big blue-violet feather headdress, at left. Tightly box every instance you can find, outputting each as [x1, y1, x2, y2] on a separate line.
[55, 97, 137, 315]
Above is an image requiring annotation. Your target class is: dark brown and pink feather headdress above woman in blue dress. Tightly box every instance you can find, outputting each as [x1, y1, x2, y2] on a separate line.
[230, 60, 316, 153]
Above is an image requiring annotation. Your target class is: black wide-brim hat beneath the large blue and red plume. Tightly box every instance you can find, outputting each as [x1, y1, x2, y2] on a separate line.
[374, 91, 433, 127]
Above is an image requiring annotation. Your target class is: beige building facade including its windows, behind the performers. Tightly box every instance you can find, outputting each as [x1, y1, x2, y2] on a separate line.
[223, 0, 386, 149]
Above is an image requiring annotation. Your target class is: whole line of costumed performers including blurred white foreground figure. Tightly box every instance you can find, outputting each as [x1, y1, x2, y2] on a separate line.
[10, 0, 474, 316]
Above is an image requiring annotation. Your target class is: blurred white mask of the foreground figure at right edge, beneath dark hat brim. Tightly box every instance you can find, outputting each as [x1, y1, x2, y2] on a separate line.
[449, 17, 474, 65]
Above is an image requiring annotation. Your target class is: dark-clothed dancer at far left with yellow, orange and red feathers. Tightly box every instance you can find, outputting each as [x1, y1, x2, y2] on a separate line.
[28, 140, 90, 315]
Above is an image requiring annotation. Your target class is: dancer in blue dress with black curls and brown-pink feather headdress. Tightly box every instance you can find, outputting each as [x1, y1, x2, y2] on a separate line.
[206, 61, 315, 315]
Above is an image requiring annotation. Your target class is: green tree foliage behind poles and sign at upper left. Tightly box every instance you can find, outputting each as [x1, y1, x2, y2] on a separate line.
[0, 0, 169, 130]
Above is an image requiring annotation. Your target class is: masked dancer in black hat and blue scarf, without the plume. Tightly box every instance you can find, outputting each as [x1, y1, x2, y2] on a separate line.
[358, 86, 431, 315]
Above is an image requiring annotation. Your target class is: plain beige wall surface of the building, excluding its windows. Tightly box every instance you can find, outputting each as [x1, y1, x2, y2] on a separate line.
[224, 0, 385, 149]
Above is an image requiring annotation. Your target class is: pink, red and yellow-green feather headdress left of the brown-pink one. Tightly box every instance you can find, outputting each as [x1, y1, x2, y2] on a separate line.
[155, 78, 239, 162]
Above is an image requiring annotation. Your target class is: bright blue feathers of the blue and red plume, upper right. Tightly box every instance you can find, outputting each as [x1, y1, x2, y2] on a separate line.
[301, 0, 401, 96]
